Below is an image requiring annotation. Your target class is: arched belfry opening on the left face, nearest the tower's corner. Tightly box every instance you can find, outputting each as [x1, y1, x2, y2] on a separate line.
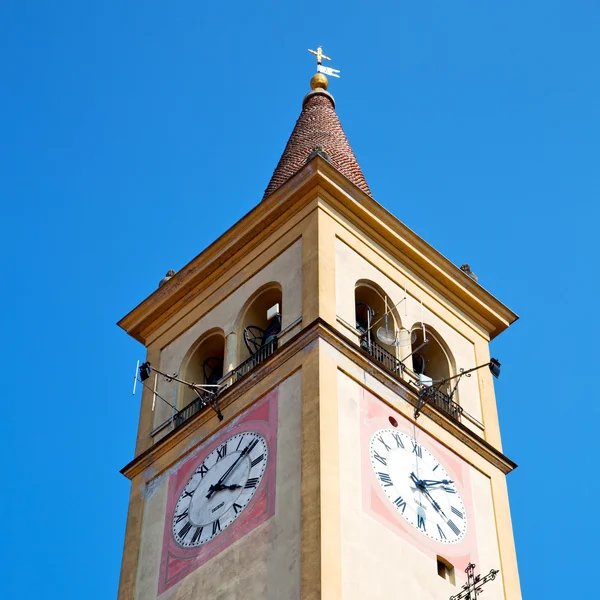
[239, 286, 283, 364]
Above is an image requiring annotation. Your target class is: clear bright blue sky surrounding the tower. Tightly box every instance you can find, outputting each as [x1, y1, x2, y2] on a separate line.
[0, 0, 600, 600]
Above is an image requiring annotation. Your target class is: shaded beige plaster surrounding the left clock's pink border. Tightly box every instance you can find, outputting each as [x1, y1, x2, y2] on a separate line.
[129, 371, 302, 600]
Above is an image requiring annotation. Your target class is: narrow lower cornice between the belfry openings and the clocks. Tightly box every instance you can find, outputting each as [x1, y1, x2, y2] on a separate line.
[121, 319, 517, 479]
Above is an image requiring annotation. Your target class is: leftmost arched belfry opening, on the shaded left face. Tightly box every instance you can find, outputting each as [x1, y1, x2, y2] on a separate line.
[179, 332, 225, 408]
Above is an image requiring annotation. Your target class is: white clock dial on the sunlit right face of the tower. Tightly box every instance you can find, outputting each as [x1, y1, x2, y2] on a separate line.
[369, 429, 467, 544]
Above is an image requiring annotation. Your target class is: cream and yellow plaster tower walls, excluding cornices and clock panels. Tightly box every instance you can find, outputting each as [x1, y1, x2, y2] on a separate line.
[119, 166, 520, 600]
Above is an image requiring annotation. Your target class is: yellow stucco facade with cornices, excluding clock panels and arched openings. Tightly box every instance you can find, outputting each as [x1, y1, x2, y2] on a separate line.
[119, 156, 521, 600]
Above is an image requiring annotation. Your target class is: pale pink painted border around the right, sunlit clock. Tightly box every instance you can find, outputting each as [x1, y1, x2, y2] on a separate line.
[360, 387, 478, 578]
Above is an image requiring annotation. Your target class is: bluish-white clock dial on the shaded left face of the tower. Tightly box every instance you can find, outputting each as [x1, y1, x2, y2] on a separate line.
[173, 431, 268, 548]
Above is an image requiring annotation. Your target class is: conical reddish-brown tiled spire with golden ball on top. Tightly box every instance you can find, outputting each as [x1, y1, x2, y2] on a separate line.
[263, 73, 371, 200]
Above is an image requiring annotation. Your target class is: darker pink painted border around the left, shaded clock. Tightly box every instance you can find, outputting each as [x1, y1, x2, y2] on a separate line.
[158, 389, 278, 595]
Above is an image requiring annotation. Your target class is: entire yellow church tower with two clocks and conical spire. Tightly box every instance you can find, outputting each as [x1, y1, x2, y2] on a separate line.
[118, 57, 521, 600]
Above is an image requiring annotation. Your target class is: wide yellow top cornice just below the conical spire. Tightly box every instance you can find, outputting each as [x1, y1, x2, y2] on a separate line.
[118, 155, 518, 345]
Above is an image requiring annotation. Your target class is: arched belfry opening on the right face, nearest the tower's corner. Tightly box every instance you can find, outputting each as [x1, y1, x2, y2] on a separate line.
[354, 281, 400, 357]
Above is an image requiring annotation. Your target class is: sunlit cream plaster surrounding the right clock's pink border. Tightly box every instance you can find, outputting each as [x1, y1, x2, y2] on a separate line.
[337, 371, 520, 600]
